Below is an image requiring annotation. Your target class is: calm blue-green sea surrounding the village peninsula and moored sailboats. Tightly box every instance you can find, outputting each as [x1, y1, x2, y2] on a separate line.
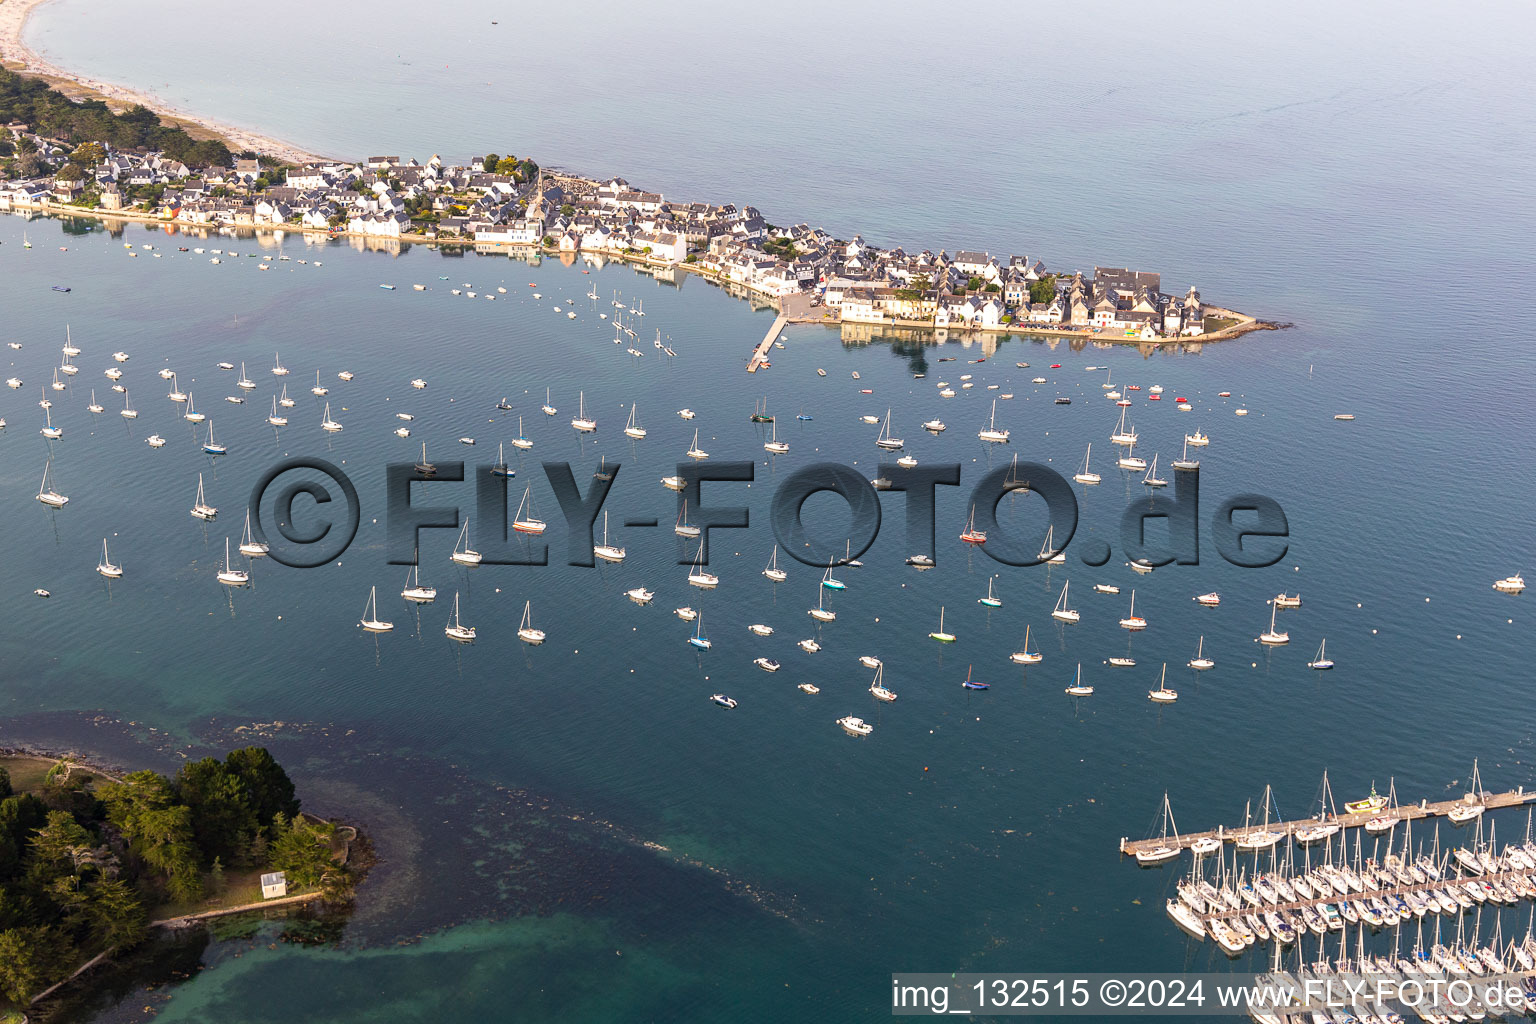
[12, 0, 1536, 1019]
